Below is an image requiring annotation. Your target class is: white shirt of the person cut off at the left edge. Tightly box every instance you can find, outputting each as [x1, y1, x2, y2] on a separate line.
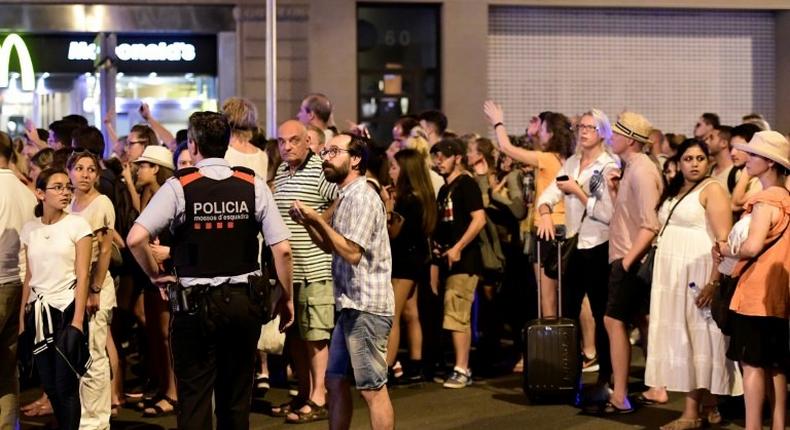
[0, 169, 36, 284]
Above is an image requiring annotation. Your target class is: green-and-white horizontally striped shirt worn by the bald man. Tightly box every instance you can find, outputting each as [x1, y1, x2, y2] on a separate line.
[274, 152, 337, 283]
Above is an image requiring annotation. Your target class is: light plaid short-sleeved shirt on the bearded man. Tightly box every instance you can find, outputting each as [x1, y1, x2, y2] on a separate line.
[332, 177, 395, 316]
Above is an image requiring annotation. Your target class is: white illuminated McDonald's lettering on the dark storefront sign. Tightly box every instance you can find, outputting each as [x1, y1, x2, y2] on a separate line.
[68, 41, 197, 62]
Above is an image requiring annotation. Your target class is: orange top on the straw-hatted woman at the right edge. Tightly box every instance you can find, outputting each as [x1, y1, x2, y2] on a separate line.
[730, 187, 790, 318]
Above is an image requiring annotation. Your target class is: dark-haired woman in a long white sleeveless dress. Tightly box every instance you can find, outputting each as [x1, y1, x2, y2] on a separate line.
[645, 139, 743, 430]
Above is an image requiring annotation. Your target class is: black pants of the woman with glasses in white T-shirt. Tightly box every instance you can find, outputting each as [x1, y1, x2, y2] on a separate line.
[31, 302, 82, 430]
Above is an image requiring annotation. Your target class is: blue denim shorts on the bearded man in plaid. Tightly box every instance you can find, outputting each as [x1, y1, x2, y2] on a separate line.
[326, 309, 392, 390]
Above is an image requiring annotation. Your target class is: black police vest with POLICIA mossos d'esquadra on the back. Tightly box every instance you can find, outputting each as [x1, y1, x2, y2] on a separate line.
[171, 167, 260, 278]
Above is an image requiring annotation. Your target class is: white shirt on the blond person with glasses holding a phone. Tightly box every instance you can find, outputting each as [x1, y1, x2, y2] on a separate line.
[537, 151, 618, 249]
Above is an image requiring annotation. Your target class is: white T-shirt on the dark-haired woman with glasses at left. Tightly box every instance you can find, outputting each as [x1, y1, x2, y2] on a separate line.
[20, 214, 93, 311]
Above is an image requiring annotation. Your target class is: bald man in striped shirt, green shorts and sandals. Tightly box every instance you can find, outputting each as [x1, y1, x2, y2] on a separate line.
[272, 120, 337, 423]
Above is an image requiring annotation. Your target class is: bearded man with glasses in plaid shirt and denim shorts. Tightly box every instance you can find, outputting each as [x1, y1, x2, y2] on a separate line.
[291, 134, 395, 430]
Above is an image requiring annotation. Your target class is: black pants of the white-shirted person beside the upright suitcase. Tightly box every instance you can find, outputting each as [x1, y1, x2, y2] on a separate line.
[562, 242, 612, 381]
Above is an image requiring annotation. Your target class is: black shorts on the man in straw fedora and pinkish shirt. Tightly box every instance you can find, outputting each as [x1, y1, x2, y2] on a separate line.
[606, 258, 650, 324]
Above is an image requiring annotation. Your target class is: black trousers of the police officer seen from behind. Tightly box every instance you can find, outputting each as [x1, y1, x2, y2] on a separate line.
[170, 284, 262, 430]
